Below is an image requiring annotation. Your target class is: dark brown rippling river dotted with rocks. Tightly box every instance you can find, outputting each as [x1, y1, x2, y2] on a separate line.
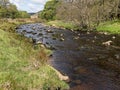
[17, 24, 120, 90]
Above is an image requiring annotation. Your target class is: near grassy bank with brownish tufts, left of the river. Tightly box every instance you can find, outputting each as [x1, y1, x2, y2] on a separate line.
[0, 22, 68, 90]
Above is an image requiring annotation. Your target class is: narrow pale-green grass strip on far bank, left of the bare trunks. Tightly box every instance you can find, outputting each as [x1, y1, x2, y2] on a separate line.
[47, 20, 79, 30]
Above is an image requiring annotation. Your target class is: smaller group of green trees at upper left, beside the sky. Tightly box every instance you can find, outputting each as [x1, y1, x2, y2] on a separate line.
[0, 0, 30, 19]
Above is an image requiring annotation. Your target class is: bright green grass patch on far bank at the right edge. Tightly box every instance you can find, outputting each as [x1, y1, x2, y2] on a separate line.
[97, 21, 120, 34]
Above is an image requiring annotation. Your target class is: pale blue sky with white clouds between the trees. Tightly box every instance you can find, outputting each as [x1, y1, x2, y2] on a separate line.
[10, 0, 48, 13]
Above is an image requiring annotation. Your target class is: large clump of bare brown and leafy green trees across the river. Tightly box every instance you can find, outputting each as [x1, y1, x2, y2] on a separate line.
[41, 0, 120, 28]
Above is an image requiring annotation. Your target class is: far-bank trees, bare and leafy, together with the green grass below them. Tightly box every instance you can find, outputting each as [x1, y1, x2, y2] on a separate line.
[39, 0, 120, 34]
